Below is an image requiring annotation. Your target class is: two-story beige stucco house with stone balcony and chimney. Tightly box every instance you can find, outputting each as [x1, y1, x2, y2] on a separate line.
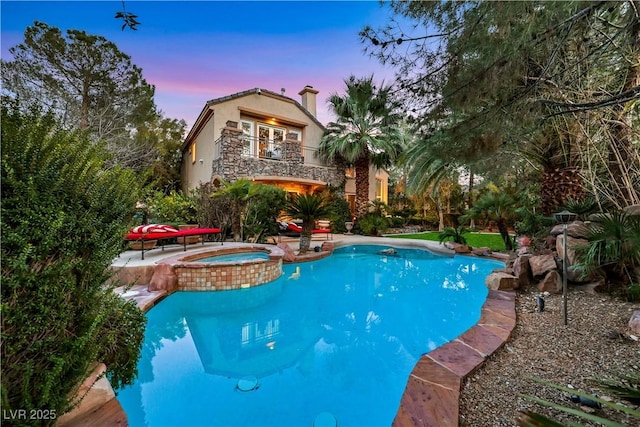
[182, 86, 388, 216]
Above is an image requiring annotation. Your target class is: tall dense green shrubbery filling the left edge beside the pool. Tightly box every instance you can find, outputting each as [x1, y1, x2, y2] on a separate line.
[0, 100, 145, 422]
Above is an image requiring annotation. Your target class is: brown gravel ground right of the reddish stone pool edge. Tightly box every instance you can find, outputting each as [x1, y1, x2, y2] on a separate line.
[460, 287, 640, 427]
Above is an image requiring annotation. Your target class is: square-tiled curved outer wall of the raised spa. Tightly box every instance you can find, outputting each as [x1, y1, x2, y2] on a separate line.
[174, 258, 282, 291]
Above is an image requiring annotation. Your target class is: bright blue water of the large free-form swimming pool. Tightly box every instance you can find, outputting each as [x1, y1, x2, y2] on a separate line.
[118, 245, 502, 427]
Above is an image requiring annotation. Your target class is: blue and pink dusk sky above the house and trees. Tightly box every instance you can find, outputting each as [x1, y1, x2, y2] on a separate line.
[0, 0, 400, 127]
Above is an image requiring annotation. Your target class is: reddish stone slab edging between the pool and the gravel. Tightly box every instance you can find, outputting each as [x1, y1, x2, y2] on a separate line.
[393, 291, 516, 427]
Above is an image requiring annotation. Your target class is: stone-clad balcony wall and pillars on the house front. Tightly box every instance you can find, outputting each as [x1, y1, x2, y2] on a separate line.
[212, 122, 344, 186]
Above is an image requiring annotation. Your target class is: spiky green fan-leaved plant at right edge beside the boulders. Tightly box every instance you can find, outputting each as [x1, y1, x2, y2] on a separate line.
[576, 211, 640, 296]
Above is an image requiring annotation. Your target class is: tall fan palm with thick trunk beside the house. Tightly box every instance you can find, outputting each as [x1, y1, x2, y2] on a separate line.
[319, 76, 401, 221]
